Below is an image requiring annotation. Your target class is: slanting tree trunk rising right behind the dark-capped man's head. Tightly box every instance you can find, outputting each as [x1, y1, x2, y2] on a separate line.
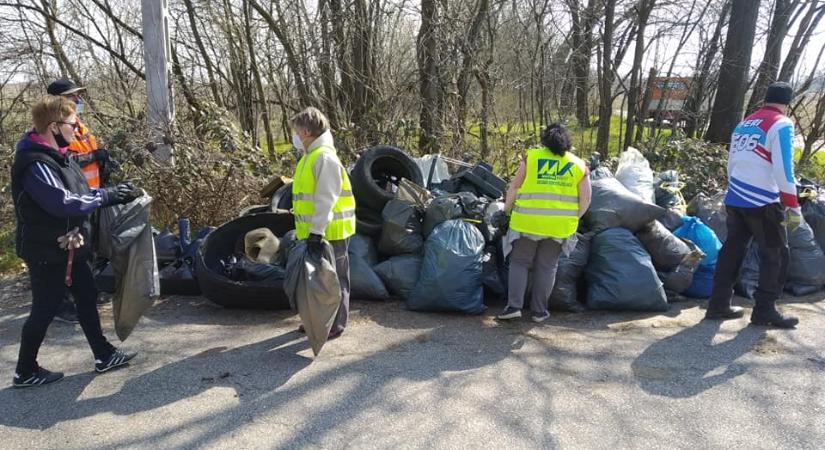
[745, 0, 799, 113]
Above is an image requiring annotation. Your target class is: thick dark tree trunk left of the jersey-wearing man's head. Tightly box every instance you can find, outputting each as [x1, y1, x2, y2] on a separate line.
[705, 0, 760, 143]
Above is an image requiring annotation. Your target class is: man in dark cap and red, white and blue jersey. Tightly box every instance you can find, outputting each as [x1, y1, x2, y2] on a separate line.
[705, 82, 802, 328]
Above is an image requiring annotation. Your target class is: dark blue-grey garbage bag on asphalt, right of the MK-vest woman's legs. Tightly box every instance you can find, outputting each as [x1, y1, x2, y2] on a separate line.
[584, 228, 668, 311]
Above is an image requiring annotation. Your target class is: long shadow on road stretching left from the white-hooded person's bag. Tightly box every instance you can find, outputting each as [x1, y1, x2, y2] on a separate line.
[0, 332, 312, 429]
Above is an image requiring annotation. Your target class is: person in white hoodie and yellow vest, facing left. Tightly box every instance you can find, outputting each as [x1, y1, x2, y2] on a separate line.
[289, 107, 355, 339]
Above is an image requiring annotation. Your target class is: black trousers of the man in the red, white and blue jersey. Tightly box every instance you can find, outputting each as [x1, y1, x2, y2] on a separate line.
[708, 203, 790, 310]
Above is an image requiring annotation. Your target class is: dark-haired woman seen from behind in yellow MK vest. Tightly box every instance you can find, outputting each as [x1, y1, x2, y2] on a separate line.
[496, 123, 591, 323]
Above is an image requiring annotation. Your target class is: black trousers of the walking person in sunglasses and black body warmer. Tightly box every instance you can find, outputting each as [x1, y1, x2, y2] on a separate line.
[17, 260, 114, 374]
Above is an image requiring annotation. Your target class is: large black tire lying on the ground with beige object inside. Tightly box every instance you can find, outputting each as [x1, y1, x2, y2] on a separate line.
[195, 211, 295, 309]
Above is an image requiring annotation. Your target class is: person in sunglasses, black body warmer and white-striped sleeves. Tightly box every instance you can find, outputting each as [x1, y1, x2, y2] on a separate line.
[11, 96, 140, 387]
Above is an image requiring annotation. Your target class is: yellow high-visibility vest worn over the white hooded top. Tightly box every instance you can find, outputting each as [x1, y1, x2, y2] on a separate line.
[292, 145, 355, 241]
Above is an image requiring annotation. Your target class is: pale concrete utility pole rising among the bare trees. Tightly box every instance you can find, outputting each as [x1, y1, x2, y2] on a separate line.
[141, 0, 175, 164]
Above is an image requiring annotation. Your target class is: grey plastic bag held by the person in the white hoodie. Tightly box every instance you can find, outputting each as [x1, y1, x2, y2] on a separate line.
[284, 240, 341, 356]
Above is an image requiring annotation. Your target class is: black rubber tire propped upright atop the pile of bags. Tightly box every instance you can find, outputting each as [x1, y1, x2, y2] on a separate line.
[350, 145, 424, 211]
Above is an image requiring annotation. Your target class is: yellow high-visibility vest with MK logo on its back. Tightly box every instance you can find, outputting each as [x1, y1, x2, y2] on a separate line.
[510, 147, 586, 239]
